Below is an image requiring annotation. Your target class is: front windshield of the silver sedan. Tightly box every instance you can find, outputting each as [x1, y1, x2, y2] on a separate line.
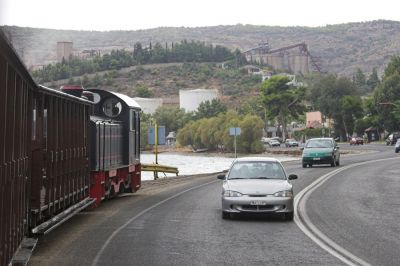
[228, 162, 286, 179]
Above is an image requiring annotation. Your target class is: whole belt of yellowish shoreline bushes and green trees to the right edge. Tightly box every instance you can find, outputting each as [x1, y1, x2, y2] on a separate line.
[142, 56, 400, 153]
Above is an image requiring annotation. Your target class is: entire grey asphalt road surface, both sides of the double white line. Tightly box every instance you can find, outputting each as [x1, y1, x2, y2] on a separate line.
[30, 145, 400, 265]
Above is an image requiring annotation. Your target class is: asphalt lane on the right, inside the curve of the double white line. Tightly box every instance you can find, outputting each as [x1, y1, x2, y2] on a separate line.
[307, 147, 400, 265]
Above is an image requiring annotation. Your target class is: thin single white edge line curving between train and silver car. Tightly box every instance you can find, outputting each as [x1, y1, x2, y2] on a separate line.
[92, 180, 219, 266]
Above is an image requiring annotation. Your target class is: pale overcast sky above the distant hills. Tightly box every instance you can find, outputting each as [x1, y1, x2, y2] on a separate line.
[0, 0, 400, 31]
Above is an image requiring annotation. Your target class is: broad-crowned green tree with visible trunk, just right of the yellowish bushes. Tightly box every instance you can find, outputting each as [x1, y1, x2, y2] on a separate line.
[261, 76, 305, 139]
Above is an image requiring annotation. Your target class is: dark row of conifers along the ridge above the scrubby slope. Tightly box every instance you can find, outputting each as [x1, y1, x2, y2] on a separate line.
[32, 40, 236, 83]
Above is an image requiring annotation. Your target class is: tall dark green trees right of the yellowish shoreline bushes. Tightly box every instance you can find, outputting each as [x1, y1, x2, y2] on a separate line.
[261, 56, 400, 140]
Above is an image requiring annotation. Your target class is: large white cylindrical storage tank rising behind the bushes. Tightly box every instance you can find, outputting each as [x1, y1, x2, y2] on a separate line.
[179, 89, 218, 112]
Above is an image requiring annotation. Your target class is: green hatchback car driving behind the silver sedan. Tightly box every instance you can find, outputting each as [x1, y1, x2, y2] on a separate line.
[302, 138, 340, 168]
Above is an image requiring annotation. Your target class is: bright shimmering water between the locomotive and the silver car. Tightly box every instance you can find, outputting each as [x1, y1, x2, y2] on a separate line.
[140, 153, 296, 180]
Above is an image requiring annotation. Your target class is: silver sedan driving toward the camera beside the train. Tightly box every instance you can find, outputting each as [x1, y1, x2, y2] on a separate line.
[218, 157, 297, 220]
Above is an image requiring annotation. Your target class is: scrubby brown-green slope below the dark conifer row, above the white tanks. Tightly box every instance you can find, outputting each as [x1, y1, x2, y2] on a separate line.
[44, 63, 261, 109]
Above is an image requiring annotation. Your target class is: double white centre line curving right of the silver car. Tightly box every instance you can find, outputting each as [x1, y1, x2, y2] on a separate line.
[294, 157, 399, 265]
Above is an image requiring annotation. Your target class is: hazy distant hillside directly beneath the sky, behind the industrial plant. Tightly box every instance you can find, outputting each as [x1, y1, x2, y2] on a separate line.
[4, 20, 400, 76]
